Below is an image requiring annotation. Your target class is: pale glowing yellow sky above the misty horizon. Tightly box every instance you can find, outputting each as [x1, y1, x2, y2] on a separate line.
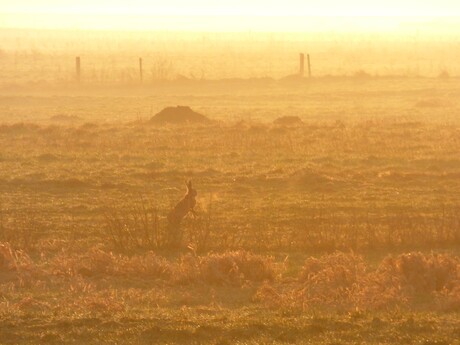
[0, 0, 460, 31]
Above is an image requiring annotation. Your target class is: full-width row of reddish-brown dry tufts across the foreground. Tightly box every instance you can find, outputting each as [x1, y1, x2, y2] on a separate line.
[0, 243, 460, 311]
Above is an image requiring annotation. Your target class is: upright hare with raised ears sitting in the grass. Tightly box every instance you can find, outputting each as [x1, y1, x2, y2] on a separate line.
[167, 181, 197, 246]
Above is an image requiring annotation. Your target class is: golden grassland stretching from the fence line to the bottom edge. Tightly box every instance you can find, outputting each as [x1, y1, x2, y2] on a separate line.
[0, 76, 460, 345]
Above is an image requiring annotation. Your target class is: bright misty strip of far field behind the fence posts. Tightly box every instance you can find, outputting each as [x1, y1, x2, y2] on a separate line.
[0, 24, 460, 87]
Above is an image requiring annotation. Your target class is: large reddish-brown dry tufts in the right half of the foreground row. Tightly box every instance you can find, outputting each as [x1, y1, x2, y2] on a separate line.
[255, 253, 460, 310]
